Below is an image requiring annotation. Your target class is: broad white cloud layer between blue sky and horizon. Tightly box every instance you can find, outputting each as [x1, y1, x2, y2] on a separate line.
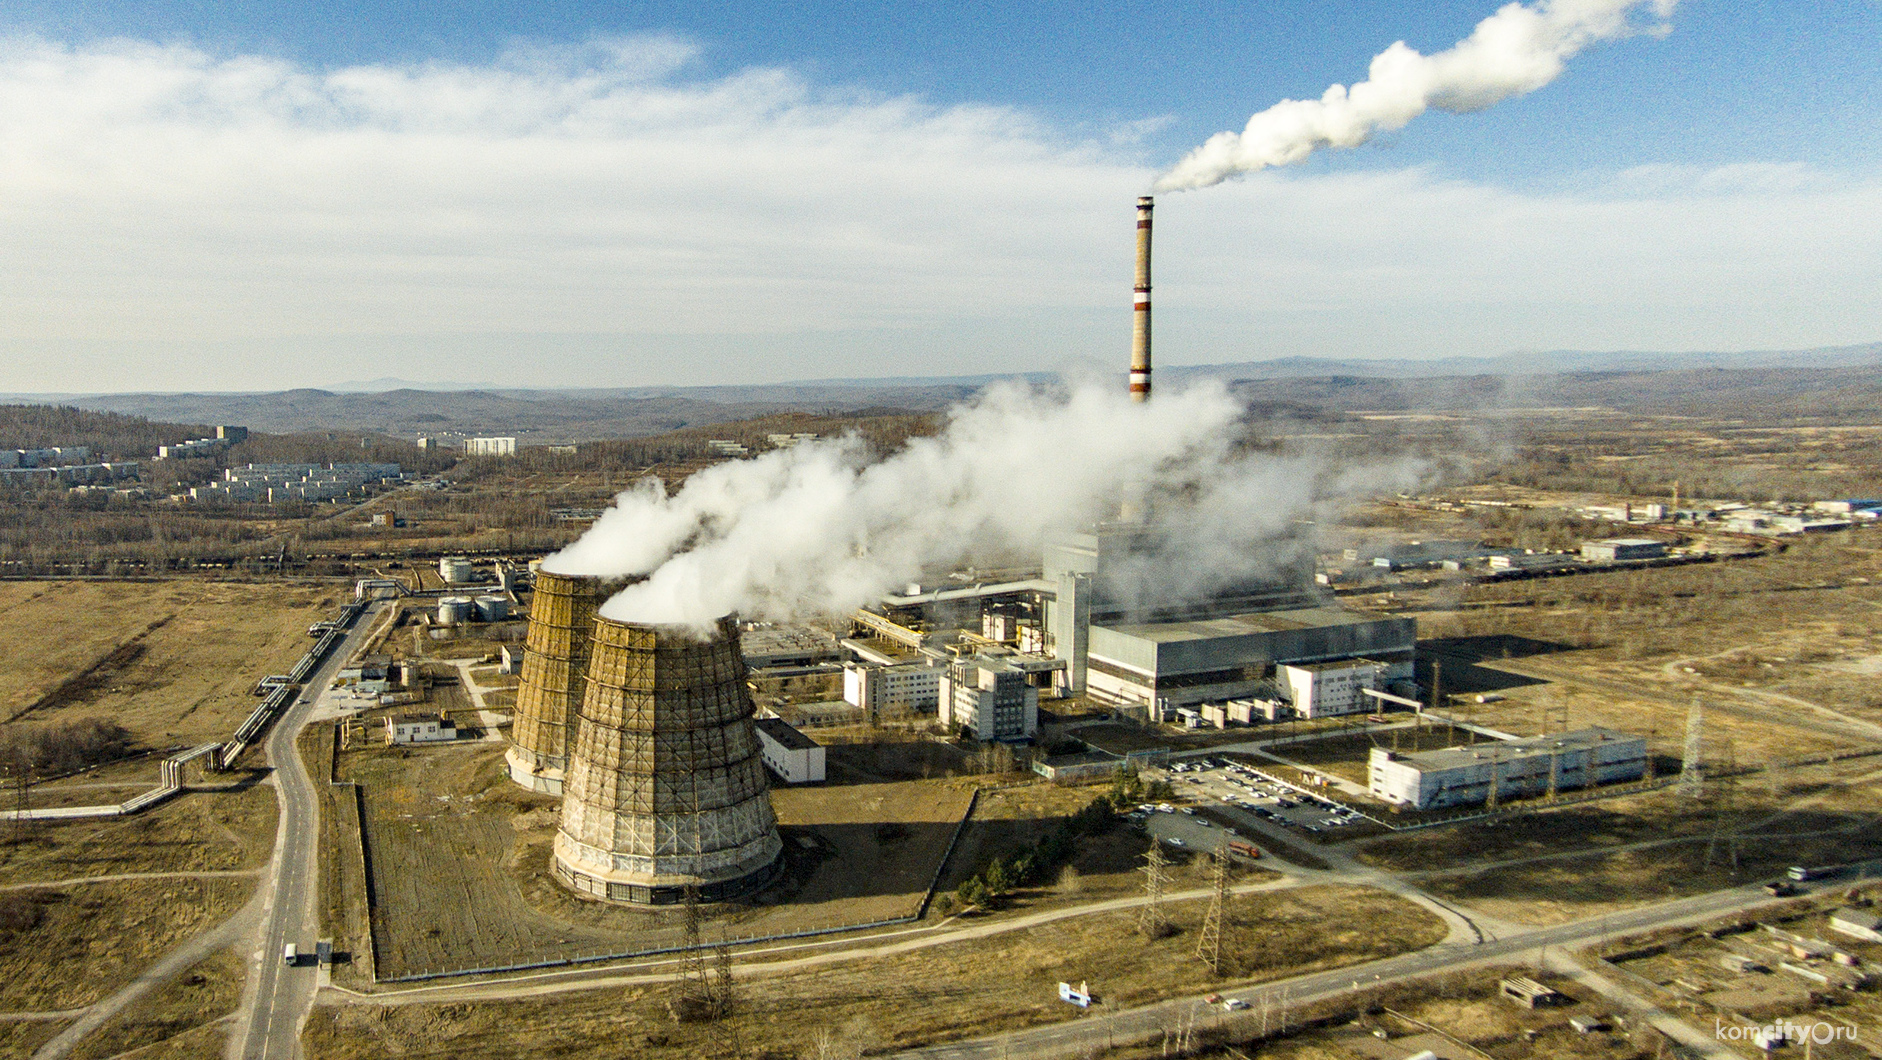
[0, 38, 1882, 390]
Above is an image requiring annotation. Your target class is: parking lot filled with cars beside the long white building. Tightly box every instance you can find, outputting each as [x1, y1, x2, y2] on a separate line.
[1133, 759, 1363, 849]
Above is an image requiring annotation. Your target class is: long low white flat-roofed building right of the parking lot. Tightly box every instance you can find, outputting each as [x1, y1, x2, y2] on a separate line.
[1370, 727, 1647, 810]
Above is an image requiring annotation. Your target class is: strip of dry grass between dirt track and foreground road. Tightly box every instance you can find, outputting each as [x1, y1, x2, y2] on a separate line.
[303, 887, 1443, 1060]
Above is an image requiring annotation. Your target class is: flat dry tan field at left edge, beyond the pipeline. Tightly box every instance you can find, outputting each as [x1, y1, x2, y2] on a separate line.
[0, 578, 343, 746]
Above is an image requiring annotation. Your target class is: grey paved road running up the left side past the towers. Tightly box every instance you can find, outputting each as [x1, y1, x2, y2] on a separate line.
[228, 604, 384, 1060]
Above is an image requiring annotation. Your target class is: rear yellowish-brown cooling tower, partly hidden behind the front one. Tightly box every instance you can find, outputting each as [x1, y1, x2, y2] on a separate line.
[504, 570, 621, 795]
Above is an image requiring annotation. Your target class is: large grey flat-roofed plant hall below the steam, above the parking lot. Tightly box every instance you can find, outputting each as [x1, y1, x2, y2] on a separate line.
[1086, 606, 1417, 708]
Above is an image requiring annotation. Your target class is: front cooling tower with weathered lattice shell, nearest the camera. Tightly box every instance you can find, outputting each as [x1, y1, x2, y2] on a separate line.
[555, 618, 783, 906]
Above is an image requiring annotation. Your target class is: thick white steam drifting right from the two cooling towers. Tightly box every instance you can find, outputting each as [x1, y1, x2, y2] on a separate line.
[544, 384, 1417, 627]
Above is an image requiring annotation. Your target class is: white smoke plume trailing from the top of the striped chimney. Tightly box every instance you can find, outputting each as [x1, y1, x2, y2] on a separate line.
[1156, 0, 1679, 192]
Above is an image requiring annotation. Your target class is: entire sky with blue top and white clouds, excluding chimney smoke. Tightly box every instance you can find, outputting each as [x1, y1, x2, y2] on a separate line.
[0, 0, 1882, 390]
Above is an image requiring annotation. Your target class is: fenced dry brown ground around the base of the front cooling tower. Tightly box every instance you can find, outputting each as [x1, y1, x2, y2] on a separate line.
[341, 744, 973, 977]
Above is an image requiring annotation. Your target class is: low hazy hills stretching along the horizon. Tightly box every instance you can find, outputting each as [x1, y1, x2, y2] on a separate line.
[11, 343, 1882, 444]
